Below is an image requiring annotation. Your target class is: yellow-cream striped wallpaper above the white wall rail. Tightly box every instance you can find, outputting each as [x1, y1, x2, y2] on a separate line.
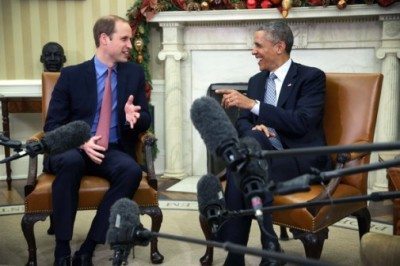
[0, 0, 139, 80]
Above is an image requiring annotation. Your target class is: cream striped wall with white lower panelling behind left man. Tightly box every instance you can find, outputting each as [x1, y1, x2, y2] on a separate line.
[0, 0, 164, 180]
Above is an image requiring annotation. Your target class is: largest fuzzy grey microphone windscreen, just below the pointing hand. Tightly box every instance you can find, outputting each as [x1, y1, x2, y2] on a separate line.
[190, 97, 238, 155]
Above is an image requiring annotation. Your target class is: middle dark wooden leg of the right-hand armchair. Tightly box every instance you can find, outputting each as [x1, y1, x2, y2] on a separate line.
[290, 228, 329, 259]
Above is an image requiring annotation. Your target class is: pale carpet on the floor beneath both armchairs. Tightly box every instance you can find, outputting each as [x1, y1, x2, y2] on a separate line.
[0, 207, 376, 266]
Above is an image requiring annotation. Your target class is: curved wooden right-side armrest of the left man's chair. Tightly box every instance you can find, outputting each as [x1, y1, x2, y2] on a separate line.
[135, 131, 158, 190]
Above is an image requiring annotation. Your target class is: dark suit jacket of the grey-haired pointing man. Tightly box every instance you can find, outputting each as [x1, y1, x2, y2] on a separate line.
[236, 62, 330, 175]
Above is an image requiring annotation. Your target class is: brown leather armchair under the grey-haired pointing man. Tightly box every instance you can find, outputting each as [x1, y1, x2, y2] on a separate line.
[200, 73, 383, 265]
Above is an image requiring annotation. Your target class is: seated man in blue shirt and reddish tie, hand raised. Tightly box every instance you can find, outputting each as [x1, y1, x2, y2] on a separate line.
[44, 16, 151, 265]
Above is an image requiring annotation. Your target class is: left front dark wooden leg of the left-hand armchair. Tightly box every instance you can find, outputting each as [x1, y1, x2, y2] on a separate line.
[21, 213, 49, 266]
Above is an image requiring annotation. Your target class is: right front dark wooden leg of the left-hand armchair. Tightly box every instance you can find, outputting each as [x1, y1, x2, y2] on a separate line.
[142, 206, 164, 264]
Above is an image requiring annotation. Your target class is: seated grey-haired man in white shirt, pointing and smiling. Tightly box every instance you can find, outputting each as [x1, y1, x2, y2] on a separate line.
[217, 22, 330, 265]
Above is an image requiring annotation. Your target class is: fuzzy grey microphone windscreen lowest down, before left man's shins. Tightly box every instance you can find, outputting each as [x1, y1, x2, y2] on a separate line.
[106, 198, 140, 245]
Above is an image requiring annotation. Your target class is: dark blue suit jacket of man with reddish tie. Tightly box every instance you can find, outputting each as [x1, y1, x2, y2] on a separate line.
[44, 59, 151, 154]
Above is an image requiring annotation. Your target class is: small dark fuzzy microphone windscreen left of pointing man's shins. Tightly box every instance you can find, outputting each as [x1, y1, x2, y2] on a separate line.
[197, 174, 226, 216]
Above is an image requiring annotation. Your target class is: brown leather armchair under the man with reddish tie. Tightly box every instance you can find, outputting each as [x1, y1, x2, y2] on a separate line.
[21, 72, 164, 265]
